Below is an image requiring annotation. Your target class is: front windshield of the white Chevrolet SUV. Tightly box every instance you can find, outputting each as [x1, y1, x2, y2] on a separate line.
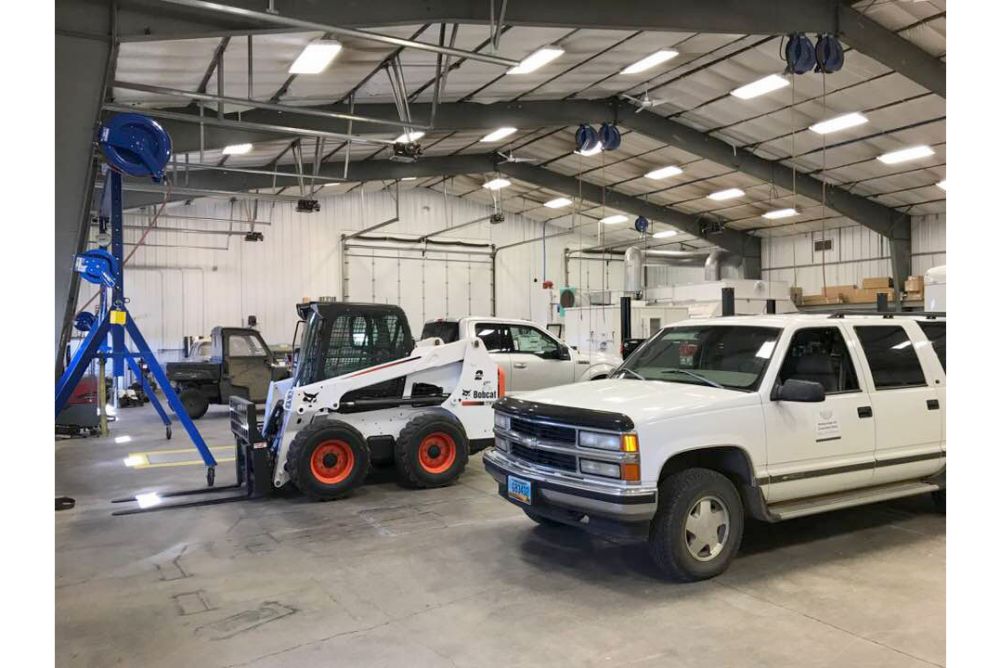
[614, 325, 781, 391]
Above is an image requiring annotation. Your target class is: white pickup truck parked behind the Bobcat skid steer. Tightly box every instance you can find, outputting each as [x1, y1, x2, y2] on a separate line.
[420, 317, 622, 393]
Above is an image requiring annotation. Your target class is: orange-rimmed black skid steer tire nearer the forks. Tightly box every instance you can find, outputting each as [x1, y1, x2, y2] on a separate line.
[285, 420, 371, 501]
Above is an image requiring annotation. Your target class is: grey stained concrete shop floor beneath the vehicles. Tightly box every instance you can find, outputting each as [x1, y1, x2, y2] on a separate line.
[55, 407, 945, 668]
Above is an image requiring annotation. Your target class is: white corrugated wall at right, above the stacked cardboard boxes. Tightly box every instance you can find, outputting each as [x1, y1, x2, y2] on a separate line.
[761, 214, 946, 294]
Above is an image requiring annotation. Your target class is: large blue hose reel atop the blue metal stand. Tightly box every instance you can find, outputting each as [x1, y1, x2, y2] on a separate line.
[100, 114, 171, 183]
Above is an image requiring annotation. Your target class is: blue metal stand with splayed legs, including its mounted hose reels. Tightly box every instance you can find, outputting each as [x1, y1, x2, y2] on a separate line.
[56, 114, 216, 486]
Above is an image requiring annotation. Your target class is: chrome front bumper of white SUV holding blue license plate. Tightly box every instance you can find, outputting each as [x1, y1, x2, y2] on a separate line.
[483, 448, 656, 524]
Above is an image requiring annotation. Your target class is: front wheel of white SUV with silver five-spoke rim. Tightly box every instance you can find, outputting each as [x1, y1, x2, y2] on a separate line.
[649, 468, 744, 582]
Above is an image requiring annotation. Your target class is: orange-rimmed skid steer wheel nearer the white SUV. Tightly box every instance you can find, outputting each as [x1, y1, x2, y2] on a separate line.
[394, 412, 469, 488]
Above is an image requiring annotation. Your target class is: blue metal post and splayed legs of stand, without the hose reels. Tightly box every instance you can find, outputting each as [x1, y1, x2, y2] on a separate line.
[56, 126, 217, 470]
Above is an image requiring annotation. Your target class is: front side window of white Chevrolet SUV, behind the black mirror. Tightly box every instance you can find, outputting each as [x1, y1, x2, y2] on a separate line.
[778, 327, 860, 394]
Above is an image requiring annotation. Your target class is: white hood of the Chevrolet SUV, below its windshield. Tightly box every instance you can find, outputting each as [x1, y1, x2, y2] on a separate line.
[517, 378, 760, 426]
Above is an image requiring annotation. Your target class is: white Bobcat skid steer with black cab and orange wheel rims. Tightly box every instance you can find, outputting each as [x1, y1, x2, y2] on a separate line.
[230, 302, 504, 500]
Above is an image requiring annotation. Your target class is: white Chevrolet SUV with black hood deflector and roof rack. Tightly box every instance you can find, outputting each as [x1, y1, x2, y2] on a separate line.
[484, 314, 945, 581]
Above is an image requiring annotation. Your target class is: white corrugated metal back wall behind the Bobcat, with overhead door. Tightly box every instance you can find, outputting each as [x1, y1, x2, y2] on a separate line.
[81, 189, 596, 360]
